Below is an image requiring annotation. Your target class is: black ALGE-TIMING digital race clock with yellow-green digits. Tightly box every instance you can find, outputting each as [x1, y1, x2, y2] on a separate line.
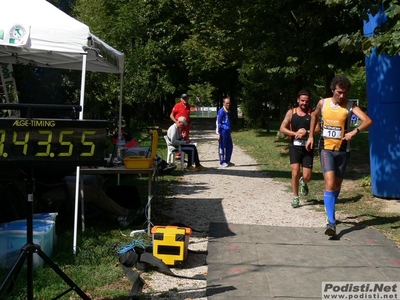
[0, 118, 108, 166]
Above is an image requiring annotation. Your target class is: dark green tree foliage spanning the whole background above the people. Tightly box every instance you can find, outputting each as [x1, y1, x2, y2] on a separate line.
[12, 0, 390, 126]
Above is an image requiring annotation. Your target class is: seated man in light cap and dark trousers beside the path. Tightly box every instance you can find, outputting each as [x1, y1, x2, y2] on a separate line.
[167, 116, 207, 171]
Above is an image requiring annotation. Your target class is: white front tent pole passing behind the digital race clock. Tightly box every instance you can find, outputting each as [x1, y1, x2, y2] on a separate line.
[72, 53, 87, 255]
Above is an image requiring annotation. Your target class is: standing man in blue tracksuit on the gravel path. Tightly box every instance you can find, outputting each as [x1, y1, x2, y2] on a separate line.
[217, 98, 235, 168]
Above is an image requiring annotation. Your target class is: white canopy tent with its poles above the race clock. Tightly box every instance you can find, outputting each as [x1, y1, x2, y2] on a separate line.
[0, 0, 124, 254]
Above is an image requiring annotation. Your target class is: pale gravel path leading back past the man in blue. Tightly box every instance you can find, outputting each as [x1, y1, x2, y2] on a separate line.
[143, 126, 325, 300]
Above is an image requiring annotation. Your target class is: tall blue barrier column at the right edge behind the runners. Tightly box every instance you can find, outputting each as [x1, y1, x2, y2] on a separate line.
[364, 9, 400, 199]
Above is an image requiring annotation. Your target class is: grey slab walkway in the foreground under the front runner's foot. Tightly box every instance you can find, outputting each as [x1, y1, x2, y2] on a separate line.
[206, 223, 400, 300]
